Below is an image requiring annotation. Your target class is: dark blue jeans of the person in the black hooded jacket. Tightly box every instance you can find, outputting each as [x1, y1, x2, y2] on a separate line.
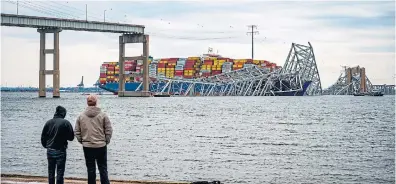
[47, 148, 66, 184]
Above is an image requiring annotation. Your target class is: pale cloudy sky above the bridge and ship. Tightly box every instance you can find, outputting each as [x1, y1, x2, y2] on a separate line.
[1, 0, 396, 88]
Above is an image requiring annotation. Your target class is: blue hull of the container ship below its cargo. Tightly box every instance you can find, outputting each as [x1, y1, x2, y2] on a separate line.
[99, 81, 311, 96]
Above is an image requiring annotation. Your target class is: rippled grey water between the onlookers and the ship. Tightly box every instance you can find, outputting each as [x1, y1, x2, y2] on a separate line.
[1, 93, 395, 183]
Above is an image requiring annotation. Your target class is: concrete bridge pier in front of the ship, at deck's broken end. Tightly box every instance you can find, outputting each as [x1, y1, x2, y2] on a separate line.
[118, 34, 151, 97]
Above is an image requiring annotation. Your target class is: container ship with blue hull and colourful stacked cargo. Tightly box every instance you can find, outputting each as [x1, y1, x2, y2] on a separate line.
[99, 50, 310, 96]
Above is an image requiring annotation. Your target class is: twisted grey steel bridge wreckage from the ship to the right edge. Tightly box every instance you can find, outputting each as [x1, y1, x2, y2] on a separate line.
[99, 42, 395, 96]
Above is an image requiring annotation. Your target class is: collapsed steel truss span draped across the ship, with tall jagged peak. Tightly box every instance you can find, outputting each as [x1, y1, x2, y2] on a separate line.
[136, 43, 322, 96]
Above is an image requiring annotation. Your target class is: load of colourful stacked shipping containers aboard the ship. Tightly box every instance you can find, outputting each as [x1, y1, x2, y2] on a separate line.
[99, 55, 281, 84]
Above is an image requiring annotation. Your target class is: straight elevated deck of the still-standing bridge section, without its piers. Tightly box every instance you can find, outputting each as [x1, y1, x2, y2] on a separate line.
[1, 13, 144, 34]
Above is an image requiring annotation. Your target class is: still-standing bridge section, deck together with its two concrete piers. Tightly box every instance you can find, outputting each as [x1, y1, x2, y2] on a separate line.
[1, 13, 149, 98]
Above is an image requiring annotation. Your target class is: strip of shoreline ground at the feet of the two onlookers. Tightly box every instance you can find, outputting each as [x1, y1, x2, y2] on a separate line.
[1, 174, 191, 184]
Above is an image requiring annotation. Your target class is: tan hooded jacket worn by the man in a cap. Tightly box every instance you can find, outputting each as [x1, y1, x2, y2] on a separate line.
[74, 106, 113, 148]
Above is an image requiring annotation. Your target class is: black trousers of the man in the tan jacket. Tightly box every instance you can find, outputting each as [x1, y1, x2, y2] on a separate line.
[83, 146, 110, 184]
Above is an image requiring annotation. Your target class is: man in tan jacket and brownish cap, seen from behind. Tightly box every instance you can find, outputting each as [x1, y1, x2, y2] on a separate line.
[75, 95, 113, 184]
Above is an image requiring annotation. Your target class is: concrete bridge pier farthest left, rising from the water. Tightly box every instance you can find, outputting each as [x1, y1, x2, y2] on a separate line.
[37, 28, 62, 98]
